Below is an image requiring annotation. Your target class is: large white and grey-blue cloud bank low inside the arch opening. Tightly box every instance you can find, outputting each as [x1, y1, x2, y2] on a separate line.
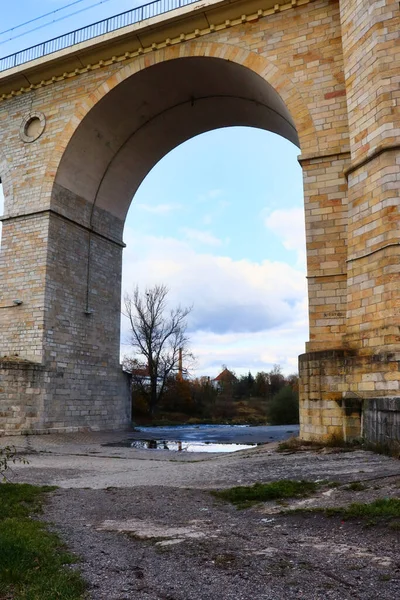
[123, 228, 307, 375]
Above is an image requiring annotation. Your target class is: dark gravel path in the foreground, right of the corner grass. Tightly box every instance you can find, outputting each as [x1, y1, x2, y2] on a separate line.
[46, 487, 400, 600]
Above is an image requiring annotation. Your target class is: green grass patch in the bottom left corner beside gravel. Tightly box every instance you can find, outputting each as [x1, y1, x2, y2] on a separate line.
[0, 483, 85, 600]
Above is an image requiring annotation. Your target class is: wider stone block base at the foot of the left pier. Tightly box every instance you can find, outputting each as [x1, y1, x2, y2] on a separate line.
[0, 358, 131, 435]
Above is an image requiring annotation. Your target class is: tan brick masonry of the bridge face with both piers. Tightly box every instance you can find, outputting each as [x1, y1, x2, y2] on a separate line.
[0, 0, 399, 436]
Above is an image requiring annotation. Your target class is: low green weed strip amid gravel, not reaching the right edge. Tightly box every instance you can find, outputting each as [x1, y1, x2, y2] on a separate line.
[212, 479, 318, 508]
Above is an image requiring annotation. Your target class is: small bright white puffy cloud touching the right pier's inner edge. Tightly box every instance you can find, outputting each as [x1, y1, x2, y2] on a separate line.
[265, 208, 306, 265]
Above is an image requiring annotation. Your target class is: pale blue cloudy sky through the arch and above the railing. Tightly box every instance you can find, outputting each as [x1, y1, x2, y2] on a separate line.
[0, 0, 308, 376]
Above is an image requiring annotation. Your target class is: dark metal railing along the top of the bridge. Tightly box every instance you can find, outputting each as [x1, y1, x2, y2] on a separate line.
[0, 0, 199, 71]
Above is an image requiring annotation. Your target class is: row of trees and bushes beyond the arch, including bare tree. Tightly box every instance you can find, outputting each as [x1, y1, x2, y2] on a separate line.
[124, 285, 298, 424]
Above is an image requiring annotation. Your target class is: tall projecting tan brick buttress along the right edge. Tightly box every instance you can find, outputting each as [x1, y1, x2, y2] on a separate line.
[340, 0, 400, 418]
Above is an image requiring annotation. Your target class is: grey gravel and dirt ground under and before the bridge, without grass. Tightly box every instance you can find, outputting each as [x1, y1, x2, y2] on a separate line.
[0, 434, 400, 600]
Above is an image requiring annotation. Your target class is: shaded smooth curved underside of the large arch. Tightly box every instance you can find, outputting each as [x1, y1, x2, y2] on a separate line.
[54, 57, 299, 235]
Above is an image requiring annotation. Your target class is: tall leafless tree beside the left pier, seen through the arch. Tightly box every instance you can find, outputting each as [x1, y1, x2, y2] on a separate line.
[123, 285, 192, 414]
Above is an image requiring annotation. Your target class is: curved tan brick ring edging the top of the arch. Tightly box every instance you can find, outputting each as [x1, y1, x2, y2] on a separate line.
[42, 42, 318, 194]
